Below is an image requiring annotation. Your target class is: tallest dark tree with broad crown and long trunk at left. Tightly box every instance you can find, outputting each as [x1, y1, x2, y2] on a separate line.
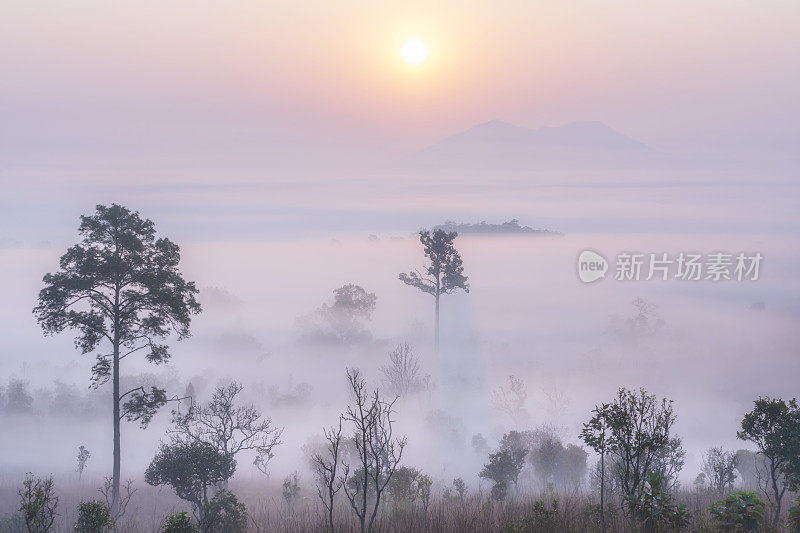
[33, 204, 200, 510]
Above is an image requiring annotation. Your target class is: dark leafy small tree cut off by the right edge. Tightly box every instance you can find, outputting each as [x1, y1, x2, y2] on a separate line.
[736, 398, 800, 526]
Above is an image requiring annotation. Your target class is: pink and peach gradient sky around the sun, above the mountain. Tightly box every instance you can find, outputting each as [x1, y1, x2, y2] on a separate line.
[0, 0, 800, 170]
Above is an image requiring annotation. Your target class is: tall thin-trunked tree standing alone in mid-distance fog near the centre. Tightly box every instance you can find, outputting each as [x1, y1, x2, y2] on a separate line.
[400, 229, 469, 353]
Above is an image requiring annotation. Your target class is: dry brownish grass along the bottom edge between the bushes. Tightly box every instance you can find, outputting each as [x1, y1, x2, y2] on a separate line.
[0, 476, 792, 533]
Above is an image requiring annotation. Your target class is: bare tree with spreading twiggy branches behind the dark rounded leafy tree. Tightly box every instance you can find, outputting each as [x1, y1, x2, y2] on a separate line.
[167, 381, 283, 475]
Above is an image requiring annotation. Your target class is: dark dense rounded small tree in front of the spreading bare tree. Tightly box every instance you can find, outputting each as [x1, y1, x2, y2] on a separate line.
[144, 442, 236, 524]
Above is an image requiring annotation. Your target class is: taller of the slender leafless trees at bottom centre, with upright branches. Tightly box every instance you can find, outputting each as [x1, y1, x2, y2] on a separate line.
[340, 369, 407, 533]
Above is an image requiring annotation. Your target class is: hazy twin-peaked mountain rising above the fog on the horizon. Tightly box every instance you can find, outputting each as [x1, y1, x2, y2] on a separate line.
[401, 120, 664, 172]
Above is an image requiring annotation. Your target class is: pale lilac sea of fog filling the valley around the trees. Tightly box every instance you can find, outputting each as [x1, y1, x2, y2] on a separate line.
[0, 172, 800, 488]
